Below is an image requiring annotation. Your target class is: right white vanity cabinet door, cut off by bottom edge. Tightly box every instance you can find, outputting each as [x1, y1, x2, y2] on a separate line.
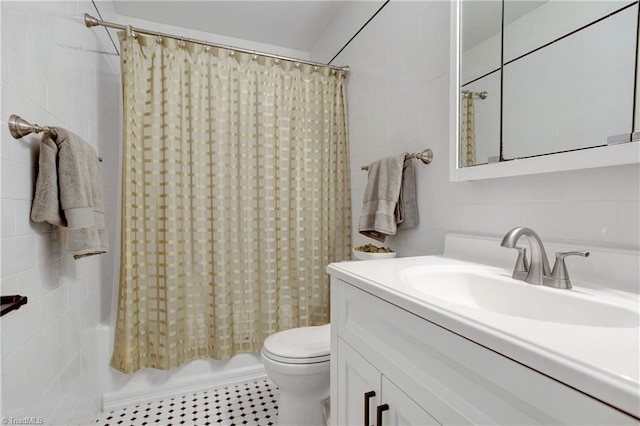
[378, 376, 440, 426]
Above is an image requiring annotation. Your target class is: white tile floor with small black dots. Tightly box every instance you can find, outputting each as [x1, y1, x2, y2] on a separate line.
[94, 379, 278, 426]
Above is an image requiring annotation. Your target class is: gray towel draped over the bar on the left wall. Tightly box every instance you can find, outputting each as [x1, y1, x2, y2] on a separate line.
[31, 127, 109, 259]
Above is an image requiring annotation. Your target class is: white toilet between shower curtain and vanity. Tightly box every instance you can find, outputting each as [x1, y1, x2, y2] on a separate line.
[261, 324, 331, 426]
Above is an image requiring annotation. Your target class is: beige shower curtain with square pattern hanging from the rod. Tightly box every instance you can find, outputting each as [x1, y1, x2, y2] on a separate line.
[112, 32, 351, 373]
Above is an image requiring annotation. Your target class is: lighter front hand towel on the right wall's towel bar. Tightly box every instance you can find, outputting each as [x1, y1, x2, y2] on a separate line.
[358, 154, 405, 242]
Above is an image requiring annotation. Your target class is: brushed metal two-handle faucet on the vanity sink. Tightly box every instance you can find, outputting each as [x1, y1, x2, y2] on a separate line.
[500, 226, 589, 289]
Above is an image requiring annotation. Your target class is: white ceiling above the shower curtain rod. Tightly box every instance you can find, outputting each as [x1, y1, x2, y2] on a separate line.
[114, 0, 347, 52]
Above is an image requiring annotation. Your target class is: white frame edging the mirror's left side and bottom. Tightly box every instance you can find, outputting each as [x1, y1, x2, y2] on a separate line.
[449, 0, 640, 182]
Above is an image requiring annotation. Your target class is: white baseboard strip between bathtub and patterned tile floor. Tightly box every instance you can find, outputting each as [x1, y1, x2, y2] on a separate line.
[102, 365, 267, 412]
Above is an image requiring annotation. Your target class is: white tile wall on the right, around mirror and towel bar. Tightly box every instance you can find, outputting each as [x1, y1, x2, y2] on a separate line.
[312, 0, 640, 255]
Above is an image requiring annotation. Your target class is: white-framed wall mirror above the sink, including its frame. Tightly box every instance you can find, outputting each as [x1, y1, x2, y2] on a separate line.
[451, 0, 640, 180]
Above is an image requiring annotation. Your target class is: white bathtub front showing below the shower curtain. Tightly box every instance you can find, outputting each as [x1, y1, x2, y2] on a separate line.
[95, 324, 267, 411]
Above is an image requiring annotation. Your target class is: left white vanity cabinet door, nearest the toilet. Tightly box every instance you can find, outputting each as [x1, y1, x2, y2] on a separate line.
[340, 339, 380, 426]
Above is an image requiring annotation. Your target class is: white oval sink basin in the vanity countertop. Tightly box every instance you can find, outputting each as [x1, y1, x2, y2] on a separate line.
[400, 265, 640, 328]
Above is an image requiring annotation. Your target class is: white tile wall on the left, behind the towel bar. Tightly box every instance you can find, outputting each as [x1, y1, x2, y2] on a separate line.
[0, 0, 121, 424]
